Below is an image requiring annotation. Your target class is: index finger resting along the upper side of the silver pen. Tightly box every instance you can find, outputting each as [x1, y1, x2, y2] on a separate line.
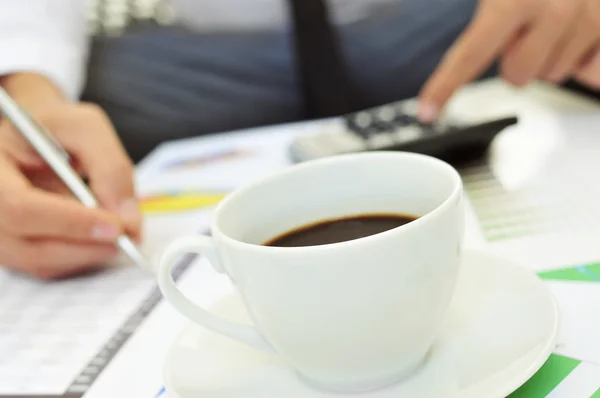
[52, 106, 142, 236]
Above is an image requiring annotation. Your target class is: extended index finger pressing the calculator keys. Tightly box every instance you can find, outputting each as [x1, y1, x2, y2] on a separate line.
[419, 2, 523, 122]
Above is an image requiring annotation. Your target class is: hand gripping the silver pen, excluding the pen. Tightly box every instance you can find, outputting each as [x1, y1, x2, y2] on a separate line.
[0, 76, 141, 278]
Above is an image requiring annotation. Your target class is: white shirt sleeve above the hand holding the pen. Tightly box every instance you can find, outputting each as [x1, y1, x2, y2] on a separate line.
[0, 0, 89, 99]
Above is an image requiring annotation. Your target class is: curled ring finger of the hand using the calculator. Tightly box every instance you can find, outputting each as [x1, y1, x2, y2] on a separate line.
[543, 5, 600, 83]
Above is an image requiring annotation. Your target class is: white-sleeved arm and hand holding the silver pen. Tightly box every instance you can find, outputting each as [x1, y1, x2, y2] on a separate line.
[0, 0, 142, 278]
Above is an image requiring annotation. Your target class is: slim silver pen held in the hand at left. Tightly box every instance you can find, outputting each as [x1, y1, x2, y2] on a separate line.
[0, 87, 151, 271]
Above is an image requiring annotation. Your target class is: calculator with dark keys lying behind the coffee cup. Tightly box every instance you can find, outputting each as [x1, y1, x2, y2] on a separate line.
[290, 98, 518, 163]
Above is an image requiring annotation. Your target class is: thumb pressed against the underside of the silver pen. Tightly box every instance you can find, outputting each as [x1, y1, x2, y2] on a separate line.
[0, 157, 121, 242]
